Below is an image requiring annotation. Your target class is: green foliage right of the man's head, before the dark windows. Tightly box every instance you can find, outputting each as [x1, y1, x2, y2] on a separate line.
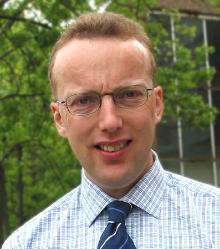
[108, 0, 217, 126]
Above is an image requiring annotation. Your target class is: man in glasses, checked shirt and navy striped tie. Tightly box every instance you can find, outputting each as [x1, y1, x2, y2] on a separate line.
[3, 13, 220, 249]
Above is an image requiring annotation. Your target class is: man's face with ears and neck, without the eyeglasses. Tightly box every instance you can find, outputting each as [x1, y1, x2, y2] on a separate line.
[51, 38, 163, 197]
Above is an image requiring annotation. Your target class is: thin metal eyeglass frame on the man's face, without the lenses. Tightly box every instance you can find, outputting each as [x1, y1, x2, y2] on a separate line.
[55, 84, 154, 116]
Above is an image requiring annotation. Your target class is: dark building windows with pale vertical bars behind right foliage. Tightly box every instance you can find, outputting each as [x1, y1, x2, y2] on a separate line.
[151, 12, 220, 186]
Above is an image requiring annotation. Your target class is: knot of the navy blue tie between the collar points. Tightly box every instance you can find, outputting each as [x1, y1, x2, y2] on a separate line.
[107, 201, 132, 222]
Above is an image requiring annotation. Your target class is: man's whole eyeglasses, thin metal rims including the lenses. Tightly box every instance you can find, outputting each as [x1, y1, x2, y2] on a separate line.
[56, 85, 153, 116]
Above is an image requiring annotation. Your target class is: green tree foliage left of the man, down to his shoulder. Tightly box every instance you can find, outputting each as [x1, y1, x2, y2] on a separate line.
[0, 0, 89, 241]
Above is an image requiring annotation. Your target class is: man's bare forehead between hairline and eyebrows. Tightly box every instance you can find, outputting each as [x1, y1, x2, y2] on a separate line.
[53, 38, 152, 97]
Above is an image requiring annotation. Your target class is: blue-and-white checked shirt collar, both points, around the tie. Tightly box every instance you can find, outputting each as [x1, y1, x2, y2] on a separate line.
[81, 152, 166, 226]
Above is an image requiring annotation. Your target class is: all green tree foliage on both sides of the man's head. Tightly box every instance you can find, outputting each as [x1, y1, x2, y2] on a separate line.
[0, 0, 216, 242]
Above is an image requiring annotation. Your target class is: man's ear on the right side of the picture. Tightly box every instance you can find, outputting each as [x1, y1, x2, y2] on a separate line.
[154, 86, 164, 124]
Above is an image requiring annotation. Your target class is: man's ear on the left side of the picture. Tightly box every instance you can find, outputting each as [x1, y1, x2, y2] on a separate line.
[50, 102, 66, 138]
